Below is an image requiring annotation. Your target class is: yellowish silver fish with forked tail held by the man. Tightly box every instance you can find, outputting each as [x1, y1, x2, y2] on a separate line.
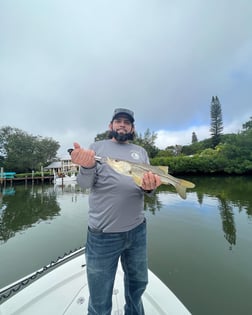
[104, 157, 195, 199]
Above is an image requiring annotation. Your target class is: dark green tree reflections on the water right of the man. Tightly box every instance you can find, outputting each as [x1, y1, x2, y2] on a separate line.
[145, 176, 252, 250]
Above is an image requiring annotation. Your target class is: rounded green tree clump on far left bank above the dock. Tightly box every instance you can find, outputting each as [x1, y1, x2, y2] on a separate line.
[0, 127, 60, 173]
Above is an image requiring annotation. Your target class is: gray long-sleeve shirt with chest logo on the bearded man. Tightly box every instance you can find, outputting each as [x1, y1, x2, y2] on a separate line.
[77, 140, 149, 233]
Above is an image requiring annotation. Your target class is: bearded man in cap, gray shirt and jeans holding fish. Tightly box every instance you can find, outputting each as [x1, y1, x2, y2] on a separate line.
[71, 108, 161, 315]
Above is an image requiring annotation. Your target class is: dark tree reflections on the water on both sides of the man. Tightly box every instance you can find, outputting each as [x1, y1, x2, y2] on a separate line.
[0, 177, 252, 249]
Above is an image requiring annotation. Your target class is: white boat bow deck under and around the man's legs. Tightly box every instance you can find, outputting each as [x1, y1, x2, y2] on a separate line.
[0, 254, 190, 315]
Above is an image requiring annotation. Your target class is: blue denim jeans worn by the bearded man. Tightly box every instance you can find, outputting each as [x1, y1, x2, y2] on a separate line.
[86, 221, 148, 315]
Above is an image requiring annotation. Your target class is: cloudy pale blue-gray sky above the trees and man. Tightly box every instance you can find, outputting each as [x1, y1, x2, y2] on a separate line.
[0, 0, 252, 156]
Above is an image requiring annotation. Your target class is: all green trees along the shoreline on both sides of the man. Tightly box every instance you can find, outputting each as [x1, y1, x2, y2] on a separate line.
[0, 96, 252, 174]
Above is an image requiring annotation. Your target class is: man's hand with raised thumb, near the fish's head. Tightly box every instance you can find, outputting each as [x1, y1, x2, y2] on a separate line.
[71, 142, 96, 168]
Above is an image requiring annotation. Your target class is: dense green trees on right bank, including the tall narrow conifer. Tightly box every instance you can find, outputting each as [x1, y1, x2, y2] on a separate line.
[151, 96, 252, 175]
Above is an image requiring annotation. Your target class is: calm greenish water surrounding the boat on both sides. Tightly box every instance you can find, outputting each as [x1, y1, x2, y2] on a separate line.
[0, 177, 252, 315]
